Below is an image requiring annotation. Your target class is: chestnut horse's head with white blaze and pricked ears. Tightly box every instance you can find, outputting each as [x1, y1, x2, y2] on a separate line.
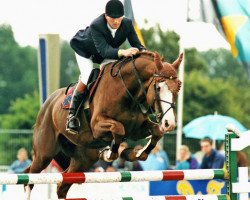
[154, 53, 183, 132]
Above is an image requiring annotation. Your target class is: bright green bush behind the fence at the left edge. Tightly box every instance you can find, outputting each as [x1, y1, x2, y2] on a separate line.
[0, 91, 40, 165]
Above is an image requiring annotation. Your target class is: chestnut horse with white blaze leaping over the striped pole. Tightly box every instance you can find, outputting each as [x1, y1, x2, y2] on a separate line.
[25, 51, 183, 198]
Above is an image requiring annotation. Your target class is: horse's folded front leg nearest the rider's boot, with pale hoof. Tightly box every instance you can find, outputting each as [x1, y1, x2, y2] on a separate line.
[92, 117, 125, 162]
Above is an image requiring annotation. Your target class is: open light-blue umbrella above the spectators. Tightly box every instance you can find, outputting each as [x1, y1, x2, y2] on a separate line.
[183, 114, 247, 140]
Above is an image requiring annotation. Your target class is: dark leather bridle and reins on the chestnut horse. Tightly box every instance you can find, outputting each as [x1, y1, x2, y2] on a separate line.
[110, 57, 177, 125]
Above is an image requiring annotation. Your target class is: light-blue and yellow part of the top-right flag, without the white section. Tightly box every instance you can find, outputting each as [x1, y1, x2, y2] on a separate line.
[213, 0, 250, 79]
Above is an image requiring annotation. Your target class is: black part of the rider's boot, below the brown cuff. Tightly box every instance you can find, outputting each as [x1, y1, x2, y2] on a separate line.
[66, 88, 86, 134]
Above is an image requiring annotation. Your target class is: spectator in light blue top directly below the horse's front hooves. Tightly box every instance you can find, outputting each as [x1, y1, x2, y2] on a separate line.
[139, 144, 169, 171]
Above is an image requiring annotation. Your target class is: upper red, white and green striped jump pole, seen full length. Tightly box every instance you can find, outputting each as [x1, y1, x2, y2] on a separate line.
[0, 169, 225, 185]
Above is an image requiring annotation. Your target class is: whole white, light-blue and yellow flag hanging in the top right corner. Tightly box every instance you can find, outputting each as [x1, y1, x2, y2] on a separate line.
[188, 0, 250, 80]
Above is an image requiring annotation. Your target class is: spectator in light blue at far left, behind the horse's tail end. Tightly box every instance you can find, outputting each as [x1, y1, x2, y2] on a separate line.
[10, 148, 31, 173]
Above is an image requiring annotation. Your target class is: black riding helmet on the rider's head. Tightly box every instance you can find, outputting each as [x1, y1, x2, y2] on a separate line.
[105, 0, 124, 18]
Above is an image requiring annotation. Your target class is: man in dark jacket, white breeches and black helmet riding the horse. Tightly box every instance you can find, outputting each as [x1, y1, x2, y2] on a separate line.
[66, 0, 145, 134]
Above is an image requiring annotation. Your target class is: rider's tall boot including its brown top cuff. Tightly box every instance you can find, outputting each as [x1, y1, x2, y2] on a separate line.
[66, 80, 88, 134]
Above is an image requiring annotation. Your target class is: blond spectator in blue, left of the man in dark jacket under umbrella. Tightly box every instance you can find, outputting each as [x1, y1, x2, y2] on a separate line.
[176, 145, 198, 170]
